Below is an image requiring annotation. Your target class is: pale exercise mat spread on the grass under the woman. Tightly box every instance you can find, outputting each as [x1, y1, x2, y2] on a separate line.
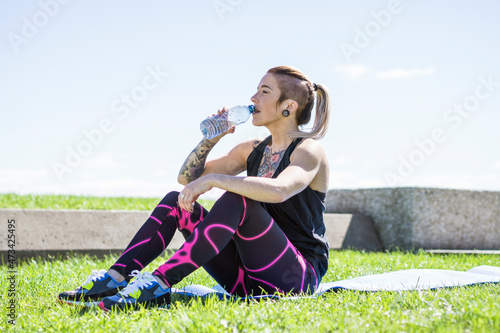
[172, 265, 500, 299]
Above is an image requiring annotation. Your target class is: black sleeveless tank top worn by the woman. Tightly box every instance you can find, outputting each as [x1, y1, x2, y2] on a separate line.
[247, 136, 328, 281]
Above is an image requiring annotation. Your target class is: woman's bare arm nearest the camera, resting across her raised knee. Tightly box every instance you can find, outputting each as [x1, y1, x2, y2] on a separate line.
[179, 140, 328, 210]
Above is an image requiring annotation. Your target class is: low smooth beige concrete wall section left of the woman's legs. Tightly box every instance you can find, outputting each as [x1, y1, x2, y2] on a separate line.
[0, 209, 183, 251]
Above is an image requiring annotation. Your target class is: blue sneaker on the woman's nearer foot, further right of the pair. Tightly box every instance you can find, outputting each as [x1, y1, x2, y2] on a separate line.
[99, 270, 170, 311]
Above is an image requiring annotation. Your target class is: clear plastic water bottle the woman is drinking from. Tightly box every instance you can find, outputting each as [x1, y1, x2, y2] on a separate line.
[200, 105, 254, 139]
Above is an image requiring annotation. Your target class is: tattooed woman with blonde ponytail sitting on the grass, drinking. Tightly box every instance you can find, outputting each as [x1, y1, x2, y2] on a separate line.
[59, 66, 330, 310]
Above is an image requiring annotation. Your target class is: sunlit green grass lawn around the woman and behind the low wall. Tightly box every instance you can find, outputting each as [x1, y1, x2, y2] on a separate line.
[0, 193, 500, 332]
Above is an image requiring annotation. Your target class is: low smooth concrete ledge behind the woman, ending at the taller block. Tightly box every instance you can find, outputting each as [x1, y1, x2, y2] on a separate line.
[0, 209, 382, 257]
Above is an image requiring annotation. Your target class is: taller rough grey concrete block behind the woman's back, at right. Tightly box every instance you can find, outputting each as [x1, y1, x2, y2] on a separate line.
[326, 187, 500, 250]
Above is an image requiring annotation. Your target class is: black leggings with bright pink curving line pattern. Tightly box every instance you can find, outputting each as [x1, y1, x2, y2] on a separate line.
[111, 192, 318, 296]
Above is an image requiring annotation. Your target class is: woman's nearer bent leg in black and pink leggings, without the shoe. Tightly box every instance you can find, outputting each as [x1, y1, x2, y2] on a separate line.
[154, 192, 317, 296]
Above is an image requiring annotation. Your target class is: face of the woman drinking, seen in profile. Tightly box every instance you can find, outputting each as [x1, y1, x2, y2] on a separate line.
[250, 73, 282, 126]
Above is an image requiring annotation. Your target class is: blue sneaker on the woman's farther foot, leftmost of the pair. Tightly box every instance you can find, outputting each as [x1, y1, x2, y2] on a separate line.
[57, 269, 127, 306]
